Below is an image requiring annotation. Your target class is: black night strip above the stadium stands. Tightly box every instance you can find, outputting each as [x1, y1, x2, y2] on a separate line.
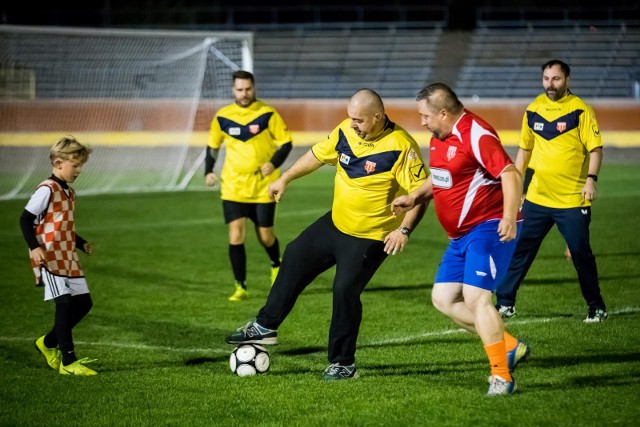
[0, 0, 640, 30]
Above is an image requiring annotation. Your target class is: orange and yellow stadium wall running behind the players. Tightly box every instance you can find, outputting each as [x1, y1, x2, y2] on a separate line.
[0, 99, 640, 147]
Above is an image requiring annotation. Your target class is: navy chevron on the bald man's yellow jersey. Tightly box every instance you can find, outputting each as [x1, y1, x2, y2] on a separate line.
[336, 129, 401, 178]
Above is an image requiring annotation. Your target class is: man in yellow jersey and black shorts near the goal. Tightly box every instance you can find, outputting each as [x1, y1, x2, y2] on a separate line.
[205, 70, 291, 301]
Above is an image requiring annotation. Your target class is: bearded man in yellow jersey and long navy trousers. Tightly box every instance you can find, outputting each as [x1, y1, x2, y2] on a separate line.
[496, 59, 608, 323]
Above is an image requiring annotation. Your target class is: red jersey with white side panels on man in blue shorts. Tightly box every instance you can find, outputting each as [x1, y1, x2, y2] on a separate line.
[429, 110, 513, 238]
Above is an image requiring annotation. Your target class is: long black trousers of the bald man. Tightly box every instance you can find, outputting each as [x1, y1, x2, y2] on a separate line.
[257, 212, 387, 365]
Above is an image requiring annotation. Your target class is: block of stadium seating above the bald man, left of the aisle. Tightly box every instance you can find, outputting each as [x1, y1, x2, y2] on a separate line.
[254, 26, 442, 98]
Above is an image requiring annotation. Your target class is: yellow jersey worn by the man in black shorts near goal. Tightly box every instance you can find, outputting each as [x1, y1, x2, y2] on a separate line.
[209, 100, 291, 203]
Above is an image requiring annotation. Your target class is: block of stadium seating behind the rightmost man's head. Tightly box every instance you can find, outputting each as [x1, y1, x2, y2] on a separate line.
[455, 26, 640, 98]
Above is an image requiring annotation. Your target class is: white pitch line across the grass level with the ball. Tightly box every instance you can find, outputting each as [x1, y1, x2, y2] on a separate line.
[0, 307, 640, 354]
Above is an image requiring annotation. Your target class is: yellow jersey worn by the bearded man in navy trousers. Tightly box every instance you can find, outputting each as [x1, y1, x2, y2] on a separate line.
[520, 93, 602, 208]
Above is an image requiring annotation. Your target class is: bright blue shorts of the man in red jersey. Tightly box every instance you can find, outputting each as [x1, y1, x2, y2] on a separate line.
[435, 220, 522, 291]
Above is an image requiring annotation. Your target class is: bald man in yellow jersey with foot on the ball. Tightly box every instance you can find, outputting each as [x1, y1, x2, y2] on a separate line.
[227, 89, 428, 380]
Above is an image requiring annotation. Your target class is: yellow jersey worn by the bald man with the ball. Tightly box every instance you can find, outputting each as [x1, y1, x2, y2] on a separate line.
[311, 119, 428, 240]
